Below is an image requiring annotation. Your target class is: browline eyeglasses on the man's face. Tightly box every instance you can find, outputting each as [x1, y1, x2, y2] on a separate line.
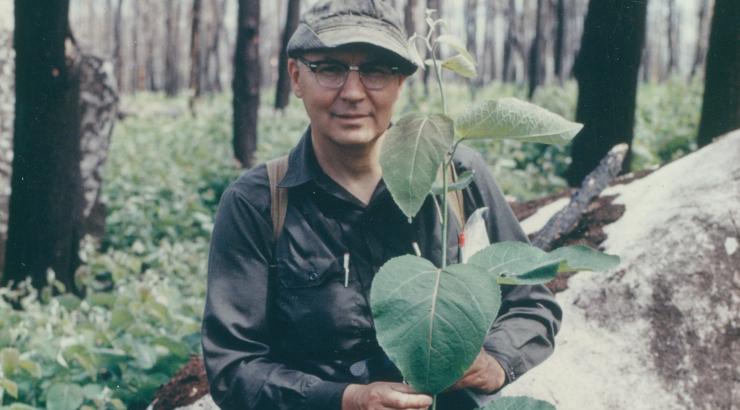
[296, 57, 399, 90]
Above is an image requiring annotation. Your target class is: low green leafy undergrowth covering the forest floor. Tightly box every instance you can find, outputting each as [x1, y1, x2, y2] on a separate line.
[0, 81, 701, 409]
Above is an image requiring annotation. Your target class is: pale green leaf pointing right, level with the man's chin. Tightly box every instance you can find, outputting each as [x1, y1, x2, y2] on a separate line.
[455, 98, 583, 145]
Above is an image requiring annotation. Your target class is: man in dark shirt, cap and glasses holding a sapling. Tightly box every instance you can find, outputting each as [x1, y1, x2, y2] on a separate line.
[203, 0, 561, 410]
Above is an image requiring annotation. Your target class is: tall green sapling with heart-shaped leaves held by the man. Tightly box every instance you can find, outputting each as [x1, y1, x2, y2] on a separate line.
[370, 11, 619, 409]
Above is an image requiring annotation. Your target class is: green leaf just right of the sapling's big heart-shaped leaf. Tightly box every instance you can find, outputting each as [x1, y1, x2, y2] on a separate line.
[468, 241, 561, 285]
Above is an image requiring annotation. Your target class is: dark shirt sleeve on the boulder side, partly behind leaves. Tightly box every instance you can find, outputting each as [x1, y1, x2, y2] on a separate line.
[465, 148, 562, 384]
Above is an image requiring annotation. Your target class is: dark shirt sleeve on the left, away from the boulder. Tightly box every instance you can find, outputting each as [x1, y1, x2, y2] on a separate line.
[202, 189, 347, 410]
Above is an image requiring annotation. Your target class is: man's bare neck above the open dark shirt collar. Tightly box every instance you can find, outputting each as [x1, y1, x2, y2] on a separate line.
[311, 136, 383, 204]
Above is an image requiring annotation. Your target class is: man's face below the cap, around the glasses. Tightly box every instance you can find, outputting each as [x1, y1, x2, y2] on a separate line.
[288, 48, 404, 147]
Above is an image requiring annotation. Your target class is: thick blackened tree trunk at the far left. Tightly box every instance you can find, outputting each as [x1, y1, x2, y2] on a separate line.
[1, 0, 83, 291]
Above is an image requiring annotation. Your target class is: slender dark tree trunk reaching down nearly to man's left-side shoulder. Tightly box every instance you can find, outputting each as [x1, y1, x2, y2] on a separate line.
[232, 0, 261, 168]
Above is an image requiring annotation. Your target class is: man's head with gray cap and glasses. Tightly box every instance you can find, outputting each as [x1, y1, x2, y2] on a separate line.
[288, 0, 417, 151]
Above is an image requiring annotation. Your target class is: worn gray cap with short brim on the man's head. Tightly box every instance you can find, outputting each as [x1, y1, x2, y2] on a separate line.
[287, 0, 418, 74]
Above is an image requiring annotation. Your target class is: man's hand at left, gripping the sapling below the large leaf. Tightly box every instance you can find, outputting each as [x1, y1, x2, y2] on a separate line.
[342, 382, 432, 410]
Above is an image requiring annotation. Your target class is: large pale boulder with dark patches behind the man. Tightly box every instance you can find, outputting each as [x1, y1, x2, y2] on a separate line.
[503, 130, 740, 410]
